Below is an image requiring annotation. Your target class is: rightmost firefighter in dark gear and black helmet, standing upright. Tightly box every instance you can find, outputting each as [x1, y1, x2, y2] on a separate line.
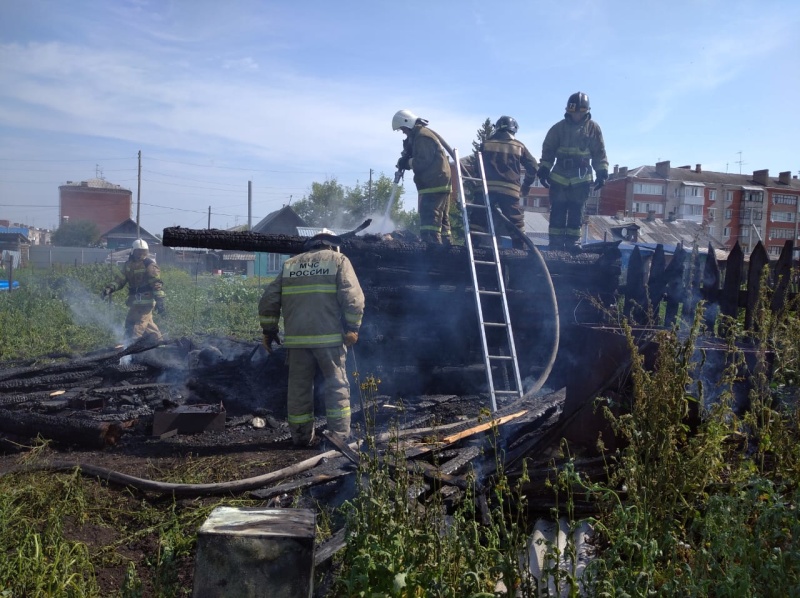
[538, 91, 608, 249]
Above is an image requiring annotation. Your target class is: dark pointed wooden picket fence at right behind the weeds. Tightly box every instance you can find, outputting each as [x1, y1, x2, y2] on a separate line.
[621, 241, 794, 331]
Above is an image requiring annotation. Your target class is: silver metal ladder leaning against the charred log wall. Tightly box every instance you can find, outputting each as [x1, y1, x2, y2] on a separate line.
[454, 150, 522, 413]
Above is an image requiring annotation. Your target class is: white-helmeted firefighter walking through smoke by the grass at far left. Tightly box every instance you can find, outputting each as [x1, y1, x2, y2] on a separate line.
[102, 239, 167, 341]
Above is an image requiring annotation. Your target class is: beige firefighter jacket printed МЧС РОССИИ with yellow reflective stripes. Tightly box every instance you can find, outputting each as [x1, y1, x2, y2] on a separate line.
[258, 248, 364, 349]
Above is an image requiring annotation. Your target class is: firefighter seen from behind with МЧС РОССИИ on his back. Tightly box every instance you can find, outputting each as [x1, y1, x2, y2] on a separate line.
[258, 229, 364, 446]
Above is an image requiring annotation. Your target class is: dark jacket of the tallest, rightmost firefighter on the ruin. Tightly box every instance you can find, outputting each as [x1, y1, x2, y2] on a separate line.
[541, 112, 608, 185]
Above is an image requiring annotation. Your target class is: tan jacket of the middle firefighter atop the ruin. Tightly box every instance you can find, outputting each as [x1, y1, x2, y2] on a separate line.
[480, 131, 539, 197]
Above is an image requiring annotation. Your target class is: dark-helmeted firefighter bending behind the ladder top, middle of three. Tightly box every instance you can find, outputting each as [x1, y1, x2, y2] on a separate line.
[465, 116, 539, 249]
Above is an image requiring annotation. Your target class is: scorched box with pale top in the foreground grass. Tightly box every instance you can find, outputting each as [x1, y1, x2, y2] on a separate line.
[192, 507, 316, 598]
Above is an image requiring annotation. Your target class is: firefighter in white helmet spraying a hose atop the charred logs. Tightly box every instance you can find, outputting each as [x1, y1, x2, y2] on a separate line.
[392, 110, 452, 244]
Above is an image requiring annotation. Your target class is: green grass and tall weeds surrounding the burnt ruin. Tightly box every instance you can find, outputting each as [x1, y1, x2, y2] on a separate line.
[0, 266, 800, 597]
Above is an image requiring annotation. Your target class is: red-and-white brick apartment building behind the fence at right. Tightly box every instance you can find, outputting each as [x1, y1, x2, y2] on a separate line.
[586, 161, 800, 257]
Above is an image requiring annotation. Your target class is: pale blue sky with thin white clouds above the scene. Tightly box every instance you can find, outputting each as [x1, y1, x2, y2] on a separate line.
[0, 0, 800, 233]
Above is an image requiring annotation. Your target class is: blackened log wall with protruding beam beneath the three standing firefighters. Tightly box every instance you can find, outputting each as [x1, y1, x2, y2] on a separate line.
[163, 227, 620, 394]
